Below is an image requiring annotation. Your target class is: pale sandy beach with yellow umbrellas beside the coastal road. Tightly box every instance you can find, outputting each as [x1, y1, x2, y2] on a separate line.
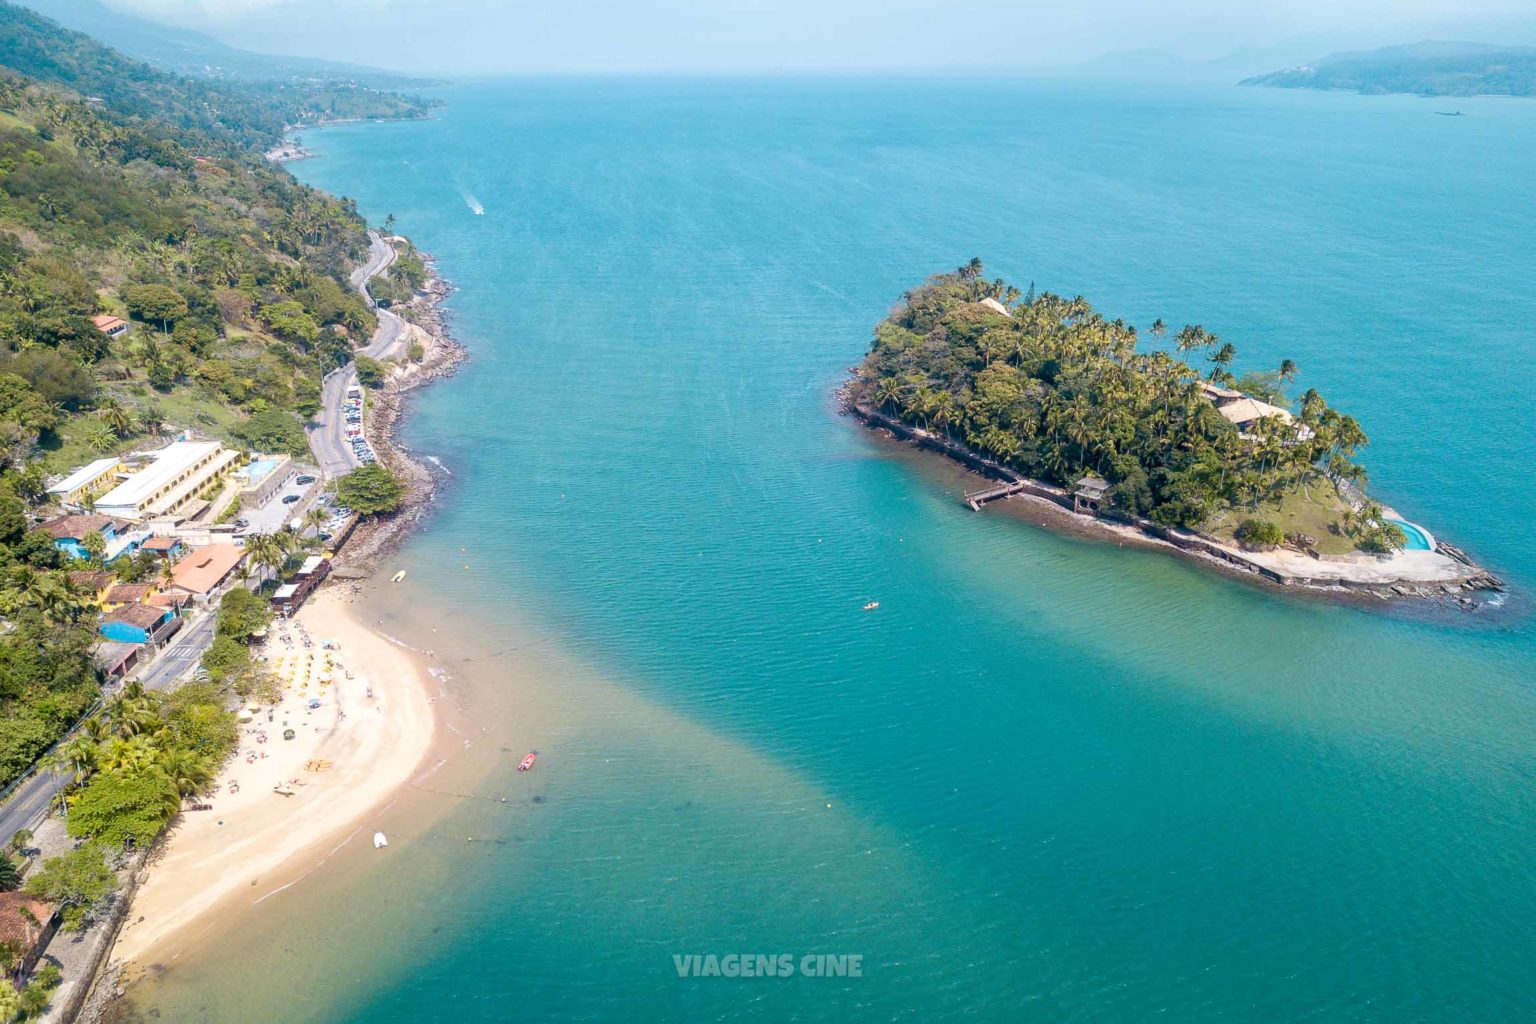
[112, 588, 438, 964]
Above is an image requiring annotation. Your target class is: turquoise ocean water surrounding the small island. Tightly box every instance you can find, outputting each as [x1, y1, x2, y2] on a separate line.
[152, 80, 1536, 1022]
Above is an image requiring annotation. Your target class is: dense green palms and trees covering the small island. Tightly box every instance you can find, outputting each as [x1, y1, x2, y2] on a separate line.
[851, 261, 1392, 547]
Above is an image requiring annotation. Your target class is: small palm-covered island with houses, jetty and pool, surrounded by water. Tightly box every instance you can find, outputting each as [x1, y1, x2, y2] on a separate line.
[843, 259, 1502, 608]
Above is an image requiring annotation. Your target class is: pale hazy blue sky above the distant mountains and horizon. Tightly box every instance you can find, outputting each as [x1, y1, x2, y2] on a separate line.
[108, 0, 1536, 74]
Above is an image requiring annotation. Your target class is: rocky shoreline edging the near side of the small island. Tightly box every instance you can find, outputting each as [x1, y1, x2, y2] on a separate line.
[836, 384, 1505, 611]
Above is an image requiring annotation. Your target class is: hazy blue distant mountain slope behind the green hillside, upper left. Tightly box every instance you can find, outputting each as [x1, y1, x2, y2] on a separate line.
[17, 0, 424, 89]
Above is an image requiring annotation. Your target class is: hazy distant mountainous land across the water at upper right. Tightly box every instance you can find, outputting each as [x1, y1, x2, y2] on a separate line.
[1241, 41, 1536, 97]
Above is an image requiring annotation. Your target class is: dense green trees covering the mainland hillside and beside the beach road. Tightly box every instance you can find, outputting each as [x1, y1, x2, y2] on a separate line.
[0, 3, 424, 810]
